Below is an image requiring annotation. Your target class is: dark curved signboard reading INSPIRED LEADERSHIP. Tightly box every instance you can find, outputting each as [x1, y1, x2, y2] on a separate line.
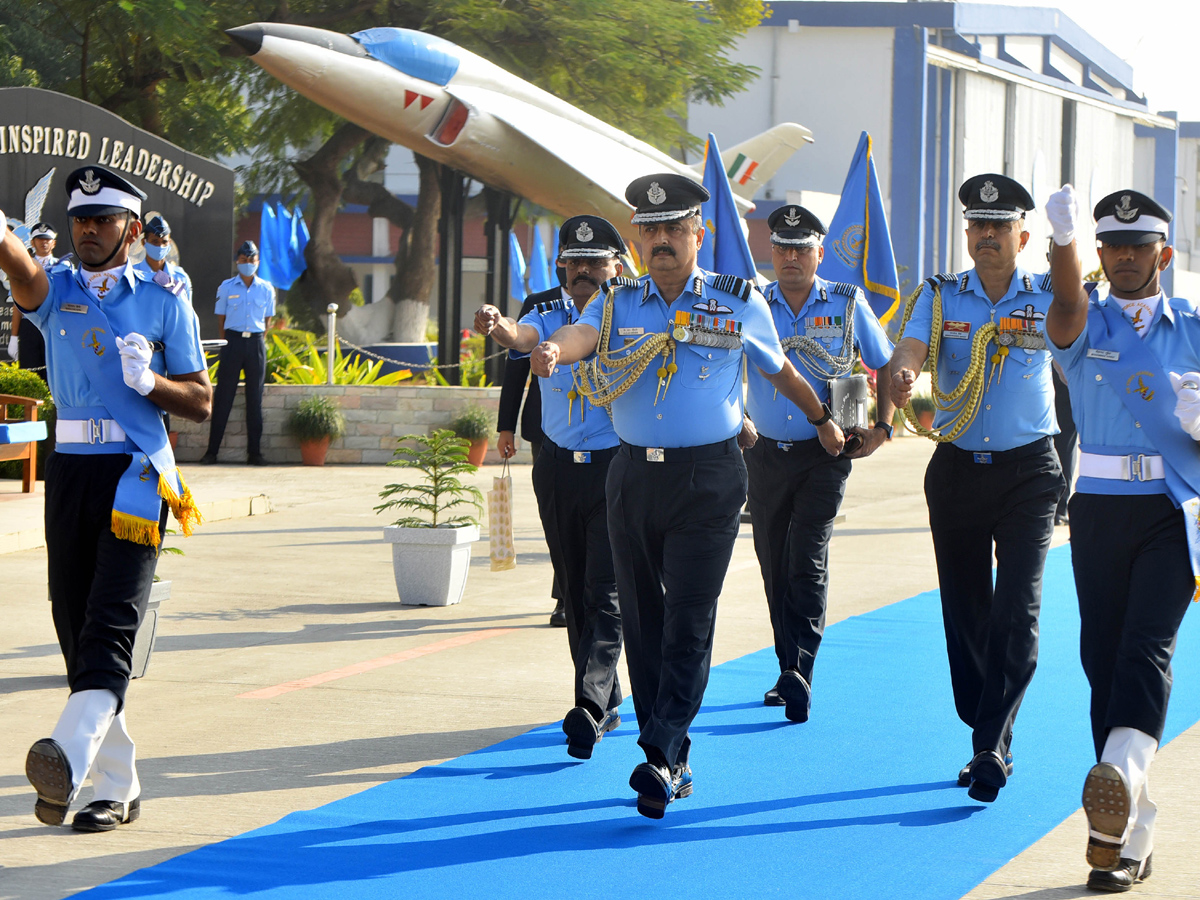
[0, 88, 234, 340]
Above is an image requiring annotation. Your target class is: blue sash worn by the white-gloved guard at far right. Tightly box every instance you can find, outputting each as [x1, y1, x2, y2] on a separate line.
[1087, 298, 1200, 600]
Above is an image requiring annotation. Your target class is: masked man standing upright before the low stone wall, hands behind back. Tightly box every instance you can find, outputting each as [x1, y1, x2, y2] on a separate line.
[199, 241, 275, 466]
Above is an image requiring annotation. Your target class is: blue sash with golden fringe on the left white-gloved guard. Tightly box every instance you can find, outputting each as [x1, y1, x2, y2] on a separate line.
[55, 272, 200, 547]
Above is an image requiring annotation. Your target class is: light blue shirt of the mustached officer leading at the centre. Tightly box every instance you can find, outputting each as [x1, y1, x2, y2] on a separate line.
[580, 269, 785, 448]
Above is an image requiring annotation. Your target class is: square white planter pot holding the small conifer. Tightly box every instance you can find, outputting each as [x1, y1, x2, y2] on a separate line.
[383, 526, 479, 606]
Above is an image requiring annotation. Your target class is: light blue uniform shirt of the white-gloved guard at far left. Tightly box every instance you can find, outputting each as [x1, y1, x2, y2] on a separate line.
[23, 264, 205, 409]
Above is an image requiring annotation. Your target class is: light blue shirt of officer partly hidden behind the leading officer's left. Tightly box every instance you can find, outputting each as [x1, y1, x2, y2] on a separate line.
[509, 295, 620, 450]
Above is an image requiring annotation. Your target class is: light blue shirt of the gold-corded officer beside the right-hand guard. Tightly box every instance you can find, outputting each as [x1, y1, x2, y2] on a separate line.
[904, 268, 1058, 451]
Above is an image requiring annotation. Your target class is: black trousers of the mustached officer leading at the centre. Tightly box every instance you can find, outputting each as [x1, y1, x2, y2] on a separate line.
[607, 438, 746, 764]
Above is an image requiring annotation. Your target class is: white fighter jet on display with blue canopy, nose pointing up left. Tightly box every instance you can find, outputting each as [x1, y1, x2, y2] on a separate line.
[227, 23, 812, 238]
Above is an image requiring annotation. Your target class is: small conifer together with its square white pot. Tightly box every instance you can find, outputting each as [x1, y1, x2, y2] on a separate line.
[376, 428, 484, 606]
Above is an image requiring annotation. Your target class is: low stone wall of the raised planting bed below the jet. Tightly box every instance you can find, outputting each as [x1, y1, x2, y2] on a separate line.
[170, 384, 530, 464]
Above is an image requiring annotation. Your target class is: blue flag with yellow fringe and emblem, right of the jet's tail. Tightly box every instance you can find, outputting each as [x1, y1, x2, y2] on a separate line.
[818, 131, 900, 324]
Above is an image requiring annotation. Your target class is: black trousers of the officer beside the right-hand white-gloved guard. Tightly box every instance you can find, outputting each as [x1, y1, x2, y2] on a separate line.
[925, 438, 1063, 756]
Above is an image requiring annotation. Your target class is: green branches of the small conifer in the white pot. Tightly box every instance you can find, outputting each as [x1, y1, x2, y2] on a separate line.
[376, 428, 484, 528]
